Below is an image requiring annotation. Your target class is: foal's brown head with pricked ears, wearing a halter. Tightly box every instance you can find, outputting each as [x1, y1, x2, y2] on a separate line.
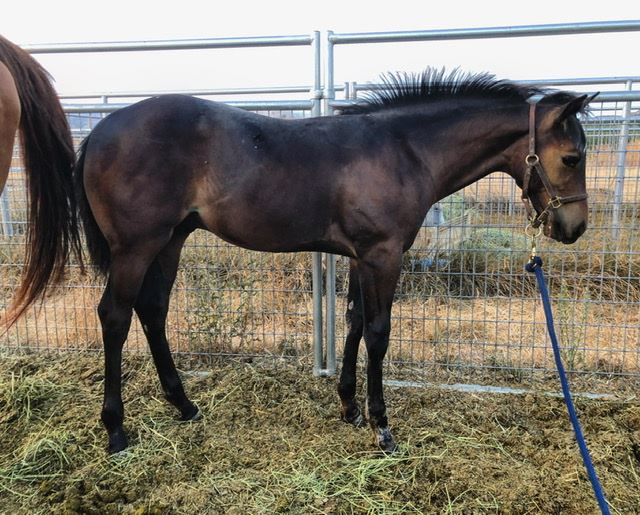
[522, 93, 595, 243]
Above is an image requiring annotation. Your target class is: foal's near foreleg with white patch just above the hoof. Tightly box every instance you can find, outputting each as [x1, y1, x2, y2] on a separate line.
[358, 245, 402, 452]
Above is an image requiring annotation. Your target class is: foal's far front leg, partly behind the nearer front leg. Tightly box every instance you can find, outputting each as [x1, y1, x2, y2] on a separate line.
[338, 259, 364, 427]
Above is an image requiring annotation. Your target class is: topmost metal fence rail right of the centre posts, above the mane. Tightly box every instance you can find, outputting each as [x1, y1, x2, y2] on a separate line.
[328, 20, 640, 45]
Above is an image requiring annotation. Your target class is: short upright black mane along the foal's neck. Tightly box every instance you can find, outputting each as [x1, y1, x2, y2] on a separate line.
[341, 68, 543, 114]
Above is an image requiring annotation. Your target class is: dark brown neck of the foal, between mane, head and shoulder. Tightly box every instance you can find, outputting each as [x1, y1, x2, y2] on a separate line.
[396, 106, 528, 201]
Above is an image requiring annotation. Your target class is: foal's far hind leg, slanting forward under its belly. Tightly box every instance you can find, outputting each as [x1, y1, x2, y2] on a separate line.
[135, 231, 200, 420]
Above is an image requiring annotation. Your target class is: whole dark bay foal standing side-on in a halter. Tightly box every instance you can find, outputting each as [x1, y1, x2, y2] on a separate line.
[50, 70, 590, 452]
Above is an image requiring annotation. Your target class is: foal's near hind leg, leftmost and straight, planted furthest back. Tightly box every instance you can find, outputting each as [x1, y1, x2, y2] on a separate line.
[98, 238, 168, 453]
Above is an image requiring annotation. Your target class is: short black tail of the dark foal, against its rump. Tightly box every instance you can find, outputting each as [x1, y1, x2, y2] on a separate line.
[73, 135, 111, 275]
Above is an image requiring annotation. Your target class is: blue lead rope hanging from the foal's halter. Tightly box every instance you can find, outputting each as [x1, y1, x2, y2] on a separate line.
[525, 256, 611, 515]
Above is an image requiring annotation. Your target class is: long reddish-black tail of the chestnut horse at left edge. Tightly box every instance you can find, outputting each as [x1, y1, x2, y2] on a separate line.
[0, 37, 82, 327]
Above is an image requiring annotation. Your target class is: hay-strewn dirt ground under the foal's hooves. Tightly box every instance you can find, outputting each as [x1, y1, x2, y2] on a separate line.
[0, 353, 640, 514]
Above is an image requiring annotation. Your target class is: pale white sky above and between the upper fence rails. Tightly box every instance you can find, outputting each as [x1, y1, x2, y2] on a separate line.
[0, 0, 640, 94]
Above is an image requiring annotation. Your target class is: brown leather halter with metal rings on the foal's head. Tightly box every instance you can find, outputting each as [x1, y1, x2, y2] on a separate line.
[522, 103, 587, 228]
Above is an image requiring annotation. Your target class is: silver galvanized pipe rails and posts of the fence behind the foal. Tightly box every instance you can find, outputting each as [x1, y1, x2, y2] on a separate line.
[15, 20, 640, 376]
